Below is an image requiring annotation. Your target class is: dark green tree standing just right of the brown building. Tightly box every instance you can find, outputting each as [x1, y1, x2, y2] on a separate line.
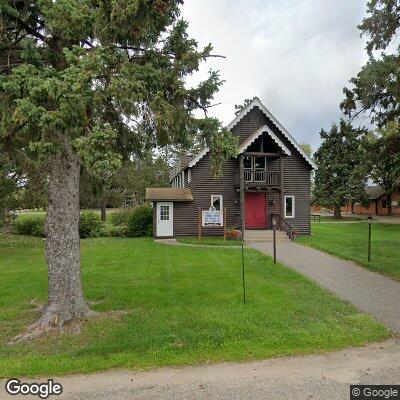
[313, 120, 366, 218]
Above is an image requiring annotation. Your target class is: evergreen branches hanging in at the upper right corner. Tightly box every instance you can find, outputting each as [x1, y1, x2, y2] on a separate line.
[341, 0, 400, 153]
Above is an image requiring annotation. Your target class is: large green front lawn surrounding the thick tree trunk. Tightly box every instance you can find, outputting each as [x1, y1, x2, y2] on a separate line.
[0, 235, 390, 377]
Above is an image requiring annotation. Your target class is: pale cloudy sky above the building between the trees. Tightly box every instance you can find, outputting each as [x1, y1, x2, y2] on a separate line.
[182, 0, 367, 150]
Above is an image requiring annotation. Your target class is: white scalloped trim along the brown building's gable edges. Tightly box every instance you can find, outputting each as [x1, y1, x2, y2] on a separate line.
[188, 97, 317, 169]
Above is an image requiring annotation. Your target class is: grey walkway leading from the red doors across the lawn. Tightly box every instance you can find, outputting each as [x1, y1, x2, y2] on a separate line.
[248, 242, 400, 334]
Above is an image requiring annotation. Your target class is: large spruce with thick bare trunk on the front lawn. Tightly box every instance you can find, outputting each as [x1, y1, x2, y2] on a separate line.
[0, 0, 236, 332]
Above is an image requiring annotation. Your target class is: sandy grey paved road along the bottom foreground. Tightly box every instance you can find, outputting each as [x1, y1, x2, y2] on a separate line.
[0, 339, 400, 400]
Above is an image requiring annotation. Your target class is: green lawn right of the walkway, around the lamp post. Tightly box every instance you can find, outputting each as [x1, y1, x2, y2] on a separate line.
[297, 222, 400, 281]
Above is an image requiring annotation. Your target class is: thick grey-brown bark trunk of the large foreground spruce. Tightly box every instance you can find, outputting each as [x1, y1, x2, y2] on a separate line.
[36, 151, 94, 327]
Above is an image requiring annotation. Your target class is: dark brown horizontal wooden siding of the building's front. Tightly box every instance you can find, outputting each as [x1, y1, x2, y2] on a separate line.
[158, 107, 311, 236]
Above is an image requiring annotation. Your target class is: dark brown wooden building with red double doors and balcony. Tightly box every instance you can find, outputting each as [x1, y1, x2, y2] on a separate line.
[146, 98, 315, 237]
